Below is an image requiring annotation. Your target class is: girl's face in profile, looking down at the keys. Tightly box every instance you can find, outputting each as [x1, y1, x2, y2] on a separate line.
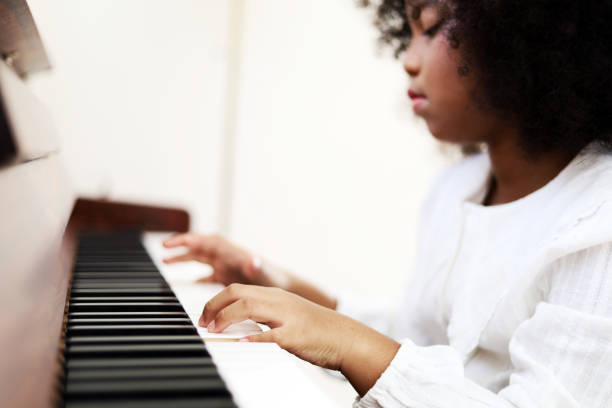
[403, 5, 510, 145]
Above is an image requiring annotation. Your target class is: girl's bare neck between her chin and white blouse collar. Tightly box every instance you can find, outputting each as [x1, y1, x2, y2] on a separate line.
[485, 137, 576, 205]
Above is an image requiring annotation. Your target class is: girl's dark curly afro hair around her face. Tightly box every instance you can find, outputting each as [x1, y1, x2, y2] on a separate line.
[360, 0, 612, 158]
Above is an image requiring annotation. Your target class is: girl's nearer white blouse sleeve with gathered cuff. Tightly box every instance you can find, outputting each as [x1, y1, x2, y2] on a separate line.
[354, 244, 612, 408]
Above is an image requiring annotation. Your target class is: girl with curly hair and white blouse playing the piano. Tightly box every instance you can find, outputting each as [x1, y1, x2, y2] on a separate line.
[165, 0, 612, 407]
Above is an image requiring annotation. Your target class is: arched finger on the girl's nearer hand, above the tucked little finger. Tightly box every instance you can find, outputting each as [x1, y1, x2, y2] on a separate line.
[208, 298, 279, 333]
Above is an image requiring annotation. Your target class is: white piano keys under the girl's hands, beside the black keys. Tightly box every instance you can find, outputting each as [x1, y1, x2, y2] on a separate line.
[142, 232, 356, 408]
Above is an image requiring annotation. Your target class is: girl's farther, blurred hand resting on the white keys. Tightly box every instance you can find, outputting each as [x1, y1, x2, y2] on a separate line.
[163, 233, 270, 286]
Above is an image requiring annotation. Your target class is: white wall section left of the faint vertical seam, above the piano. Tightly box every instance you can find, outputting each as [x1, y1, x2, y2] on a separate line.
[23, 0, 229, 229]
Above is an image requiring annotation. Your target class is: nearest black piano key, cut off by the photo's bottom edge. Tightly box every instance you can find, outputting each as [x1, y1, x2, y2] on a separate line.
[66, 396, 236, 408]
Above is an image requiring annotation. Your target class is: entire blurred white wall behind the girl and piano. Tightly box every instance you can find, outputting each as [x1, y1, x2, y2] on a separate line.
[28, 0, 449, 299]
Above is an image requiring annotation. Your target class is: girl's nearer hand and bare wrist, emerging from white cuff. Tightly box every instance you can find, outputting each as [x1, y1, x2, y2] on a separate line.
[199, 284, 399, 395]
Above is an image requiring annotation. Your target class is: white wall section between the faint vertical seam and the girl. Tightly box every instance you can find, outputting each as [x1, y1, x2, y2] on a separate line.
[231, 0, 450, 297]
